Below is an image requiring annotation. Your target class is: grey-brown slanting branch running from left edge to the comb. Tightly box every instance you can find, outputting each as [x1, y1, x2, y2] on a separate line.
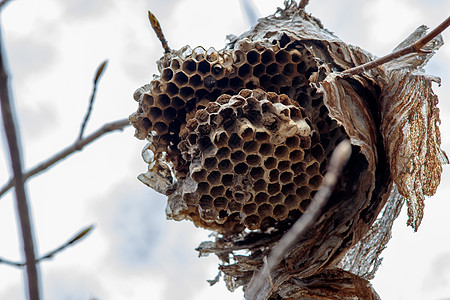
[0, 119, 130, 197]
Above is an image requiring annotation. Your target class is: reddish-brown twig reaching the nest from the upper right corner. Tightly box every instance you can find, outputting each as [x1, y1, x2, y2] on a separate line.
[341, 17, 450, 77]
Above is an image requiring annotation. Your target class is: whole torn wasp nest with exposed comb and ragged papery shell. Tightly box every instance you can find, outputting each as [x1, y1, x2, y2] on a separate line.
[130, 1, 447, 299]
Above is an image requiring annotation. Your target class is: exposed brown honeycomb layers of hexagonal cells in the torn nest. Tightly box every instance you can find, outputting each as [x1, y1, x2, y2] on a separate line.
[130, 36, 347, 233]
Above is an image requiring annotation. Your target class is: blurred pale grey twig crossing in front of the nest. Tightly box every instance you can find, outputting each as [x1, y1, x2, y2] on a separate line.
[247, 140, 351, 298]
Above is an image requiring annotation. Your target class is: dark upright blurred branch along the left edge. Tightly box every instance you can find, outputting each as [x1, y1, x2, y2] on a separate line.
[0, 22, 40, 300]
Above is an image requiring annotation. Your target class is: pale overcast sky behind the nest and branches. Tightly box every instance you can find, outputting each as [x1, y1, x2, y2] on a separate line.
[0, 0, 450, 300]
